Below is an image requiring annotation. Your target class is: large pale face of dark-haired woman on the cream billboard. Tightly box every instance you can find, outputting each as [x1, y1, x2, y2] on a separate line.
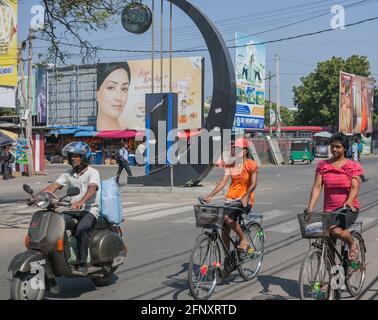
[97, 69, 130, 118]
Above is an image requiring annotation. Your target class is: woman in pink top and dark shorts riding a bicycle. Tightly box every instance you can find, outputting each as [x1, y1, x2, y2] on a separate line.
[307, 133, 364, 261]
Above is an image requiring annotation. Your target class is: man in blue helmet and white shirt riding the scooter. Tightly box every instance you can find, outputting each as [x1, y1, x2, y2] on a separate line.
[42, 141, 100, 274]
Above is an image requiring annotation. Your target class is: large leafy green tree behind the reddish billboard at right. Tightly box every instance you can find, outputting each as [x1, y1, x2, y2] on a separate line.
[293, 55, 370, 127]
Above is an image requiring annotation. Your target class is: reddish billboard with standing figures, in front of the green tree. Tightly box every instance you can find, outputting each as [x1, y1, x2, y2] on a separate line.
[339, 72, 374, 135]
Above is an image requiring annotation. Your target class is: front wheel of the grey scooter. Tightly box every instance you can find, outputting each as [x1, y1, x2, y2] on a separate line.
[10, 272, 45, 300]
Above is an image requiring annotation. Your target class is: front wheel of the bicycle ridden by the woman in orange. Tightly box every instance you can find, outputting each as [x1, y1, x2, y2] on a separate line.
[188, 236, 221, 300]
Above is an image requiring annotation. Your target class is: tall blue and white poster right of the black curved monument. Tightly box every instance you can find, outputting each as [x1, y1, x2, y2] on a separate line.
[235, 33, 266, 130]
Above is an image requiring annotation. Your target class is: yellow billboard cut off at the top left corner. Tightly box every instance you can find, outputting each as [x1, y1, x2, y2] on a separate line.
[0, 0, 17, 87]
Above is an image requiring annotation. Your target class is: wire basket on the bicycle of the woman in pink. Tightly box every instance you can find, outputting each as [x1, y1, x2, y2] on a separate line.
[298, 212, 332, 239]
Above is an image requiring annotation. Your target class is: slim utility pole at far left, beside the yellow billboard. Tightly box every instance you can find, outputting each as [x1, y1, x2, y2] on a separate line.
[25, 28, 35, 176]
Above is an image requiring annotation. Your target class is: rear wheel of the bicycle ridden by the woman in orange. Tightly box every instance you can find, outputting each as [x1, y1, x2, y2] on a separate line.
[239, 222, 265, 281]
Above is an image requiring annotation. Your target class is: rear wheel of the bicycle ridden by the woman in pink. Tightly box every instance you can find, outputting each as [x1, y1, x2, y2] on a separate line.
[345, 232, 366, 297]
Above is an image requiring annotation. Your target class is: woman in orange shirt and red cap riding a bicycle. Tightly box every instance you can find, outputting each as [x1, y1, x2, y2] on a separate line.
[204, 138, 258, 250]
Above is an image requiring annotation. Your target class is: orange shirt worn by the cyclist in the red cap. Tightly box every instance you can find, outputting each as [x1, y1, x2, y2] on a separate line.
[225, 159, 258, 206]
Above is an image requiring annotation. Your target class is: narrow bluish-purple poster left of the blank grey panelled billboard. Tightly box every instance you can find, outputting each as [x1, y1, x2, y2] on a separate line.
[35, 66, 47, 124]
